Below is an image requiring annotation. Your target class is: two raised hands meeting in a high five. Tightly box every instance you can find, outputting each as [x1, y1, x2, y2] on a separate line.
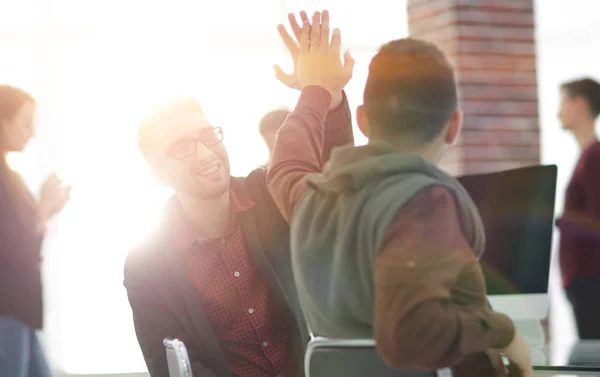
[275, 11, 354, 108]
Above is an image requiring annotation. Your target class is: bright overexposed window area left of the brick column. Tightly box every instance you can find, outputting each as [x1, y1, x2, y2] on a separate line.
[0, 0, 406, 374]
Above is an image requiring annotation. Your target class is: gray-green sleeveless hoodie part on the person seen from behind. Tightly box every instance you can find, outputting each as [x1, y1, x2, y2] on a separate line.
[291, 142, 485, 338]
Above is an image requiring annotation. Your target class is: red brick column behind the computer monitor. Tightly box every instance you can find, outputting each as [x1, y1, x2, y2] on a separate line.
[407, 0, 540, 175]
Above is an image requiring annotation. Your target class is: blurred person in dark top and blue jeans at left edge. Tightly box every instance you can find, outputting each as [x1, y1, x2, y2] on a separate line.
[0, 85, 71, 377]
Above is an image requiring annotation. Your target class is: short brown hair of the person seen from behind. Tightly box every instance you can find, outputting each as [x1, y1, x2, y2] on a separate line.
[363, 38, 458, 146]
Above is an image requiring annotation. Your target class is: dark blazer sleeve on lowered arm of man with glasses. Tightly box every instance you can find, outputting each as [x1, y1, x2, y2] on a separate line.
[124, 258, 217, 377]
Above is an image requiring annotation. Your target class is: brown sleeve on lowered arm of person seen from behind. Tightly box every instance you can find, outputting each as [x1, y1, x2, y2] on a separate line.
[374, 186, 515, 369]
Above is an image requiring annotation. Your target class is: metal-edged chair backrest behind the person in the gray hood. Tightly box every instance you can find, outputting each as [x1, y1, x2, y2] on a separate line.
[304, 337, 452, 377]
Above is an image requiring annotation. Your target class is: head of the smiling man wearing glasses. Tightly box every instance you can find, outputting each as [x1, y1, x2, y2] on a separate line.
[138, 98, 230, 200]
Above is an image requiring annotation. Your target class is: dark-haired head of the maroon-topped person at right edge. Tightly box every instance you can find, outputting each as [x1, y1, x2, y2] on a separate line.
[558, 78, 600, 132]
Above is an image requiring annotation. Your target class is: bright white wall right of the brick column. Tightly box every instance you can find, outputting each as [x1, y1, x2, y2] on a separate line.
[535, 0, 600, 363]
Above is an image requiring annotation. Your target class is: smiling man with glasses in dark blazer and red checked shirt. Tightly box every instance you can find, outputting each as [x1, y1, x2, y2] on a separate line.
[124, 14, 353, 377]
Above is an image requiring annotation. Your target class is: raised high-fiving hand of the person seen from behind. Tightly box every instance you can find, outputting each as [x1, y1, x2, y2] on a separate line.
[296, 11, 354, 97]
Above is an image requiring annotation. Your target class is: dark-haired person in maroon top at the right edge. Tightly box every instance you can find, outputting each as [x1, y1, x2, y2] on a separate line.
[557, 78, 600, 339]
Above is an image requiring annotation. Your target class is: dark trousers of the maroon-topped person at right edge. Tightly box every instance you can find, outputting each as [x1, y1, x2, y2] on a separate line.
[566, 276, 600, 339]
